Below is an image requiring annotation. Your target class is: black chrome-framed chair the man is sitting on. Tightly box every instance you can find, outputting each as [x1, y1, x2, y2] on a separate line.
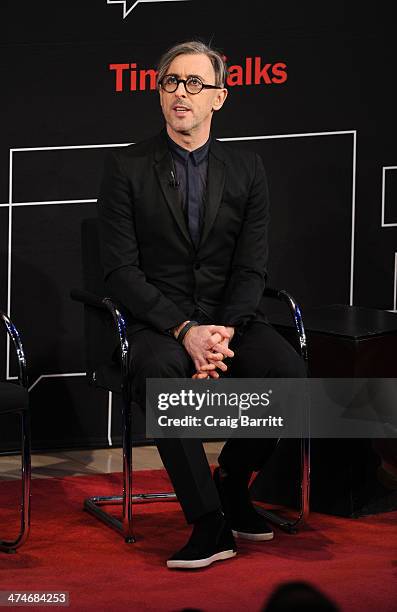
[71, 219, 310, 543]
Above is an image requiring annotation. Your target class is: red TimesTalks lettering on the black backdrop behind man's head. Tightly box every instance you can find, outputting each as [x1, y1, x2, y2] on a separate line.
[109, 57, 288, 92]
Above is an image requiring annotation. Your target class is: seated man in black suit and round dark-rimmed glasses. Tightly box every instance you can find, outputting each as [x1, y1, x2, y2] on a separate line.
[99, 41, 305, 568]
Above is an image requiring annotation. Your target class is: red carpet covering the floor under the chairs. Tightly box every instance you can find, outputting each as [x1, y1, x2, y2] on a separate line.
[0, 470, 397, 612]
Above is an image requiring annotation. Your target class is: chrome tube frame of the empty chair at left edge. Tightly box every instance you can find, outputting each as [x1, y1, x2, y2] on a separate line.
[0, 311, 31, 553]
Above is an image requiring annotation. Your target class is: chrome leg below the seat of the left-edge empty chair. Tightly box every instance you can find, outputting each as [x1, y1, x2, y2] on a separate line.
[0, 410, 31, 553]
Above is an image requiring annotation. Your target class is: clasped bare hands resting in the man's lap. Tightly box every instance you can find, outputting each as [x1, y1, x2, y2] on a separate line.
[175, 325, 234, 379]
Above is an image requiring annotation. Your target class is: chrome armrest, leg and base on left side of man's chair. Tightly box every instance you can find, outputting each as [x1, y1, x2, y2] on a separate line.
[71, 290, 176, 544]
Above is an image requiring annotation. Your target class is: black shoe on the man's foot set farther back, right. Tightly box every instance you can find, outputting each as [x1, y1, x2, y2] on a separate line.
[214, 468, 274, 542]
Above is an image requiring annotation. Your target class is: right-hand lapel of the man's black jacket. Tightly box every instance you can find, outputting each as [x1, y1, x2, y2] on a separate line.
[200, 141, 226, 246]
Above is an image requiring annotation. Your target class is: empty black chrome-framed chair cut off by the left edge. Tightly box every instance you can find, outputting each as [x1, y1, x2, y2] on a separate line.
[0, 311, 31, 553]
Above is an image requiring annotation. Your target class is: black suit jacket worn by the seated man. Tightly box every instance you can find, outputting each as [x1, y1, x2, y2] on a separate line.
[98, 132, 269, 331]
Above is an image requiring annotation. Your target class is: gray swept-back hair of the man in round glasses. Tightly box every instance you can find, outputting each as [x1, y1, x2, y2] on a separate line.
[157, 40, 227, 87]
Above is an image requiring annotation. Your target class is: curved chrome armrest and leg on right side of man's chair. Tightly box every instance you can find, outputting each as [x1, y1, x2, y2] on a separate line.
[256, 287, 310, 533]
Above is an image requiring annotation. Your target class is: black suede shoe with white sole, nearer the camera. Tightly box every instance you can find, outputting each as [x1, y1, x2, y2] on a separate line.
[167, 513, 237, 569]
